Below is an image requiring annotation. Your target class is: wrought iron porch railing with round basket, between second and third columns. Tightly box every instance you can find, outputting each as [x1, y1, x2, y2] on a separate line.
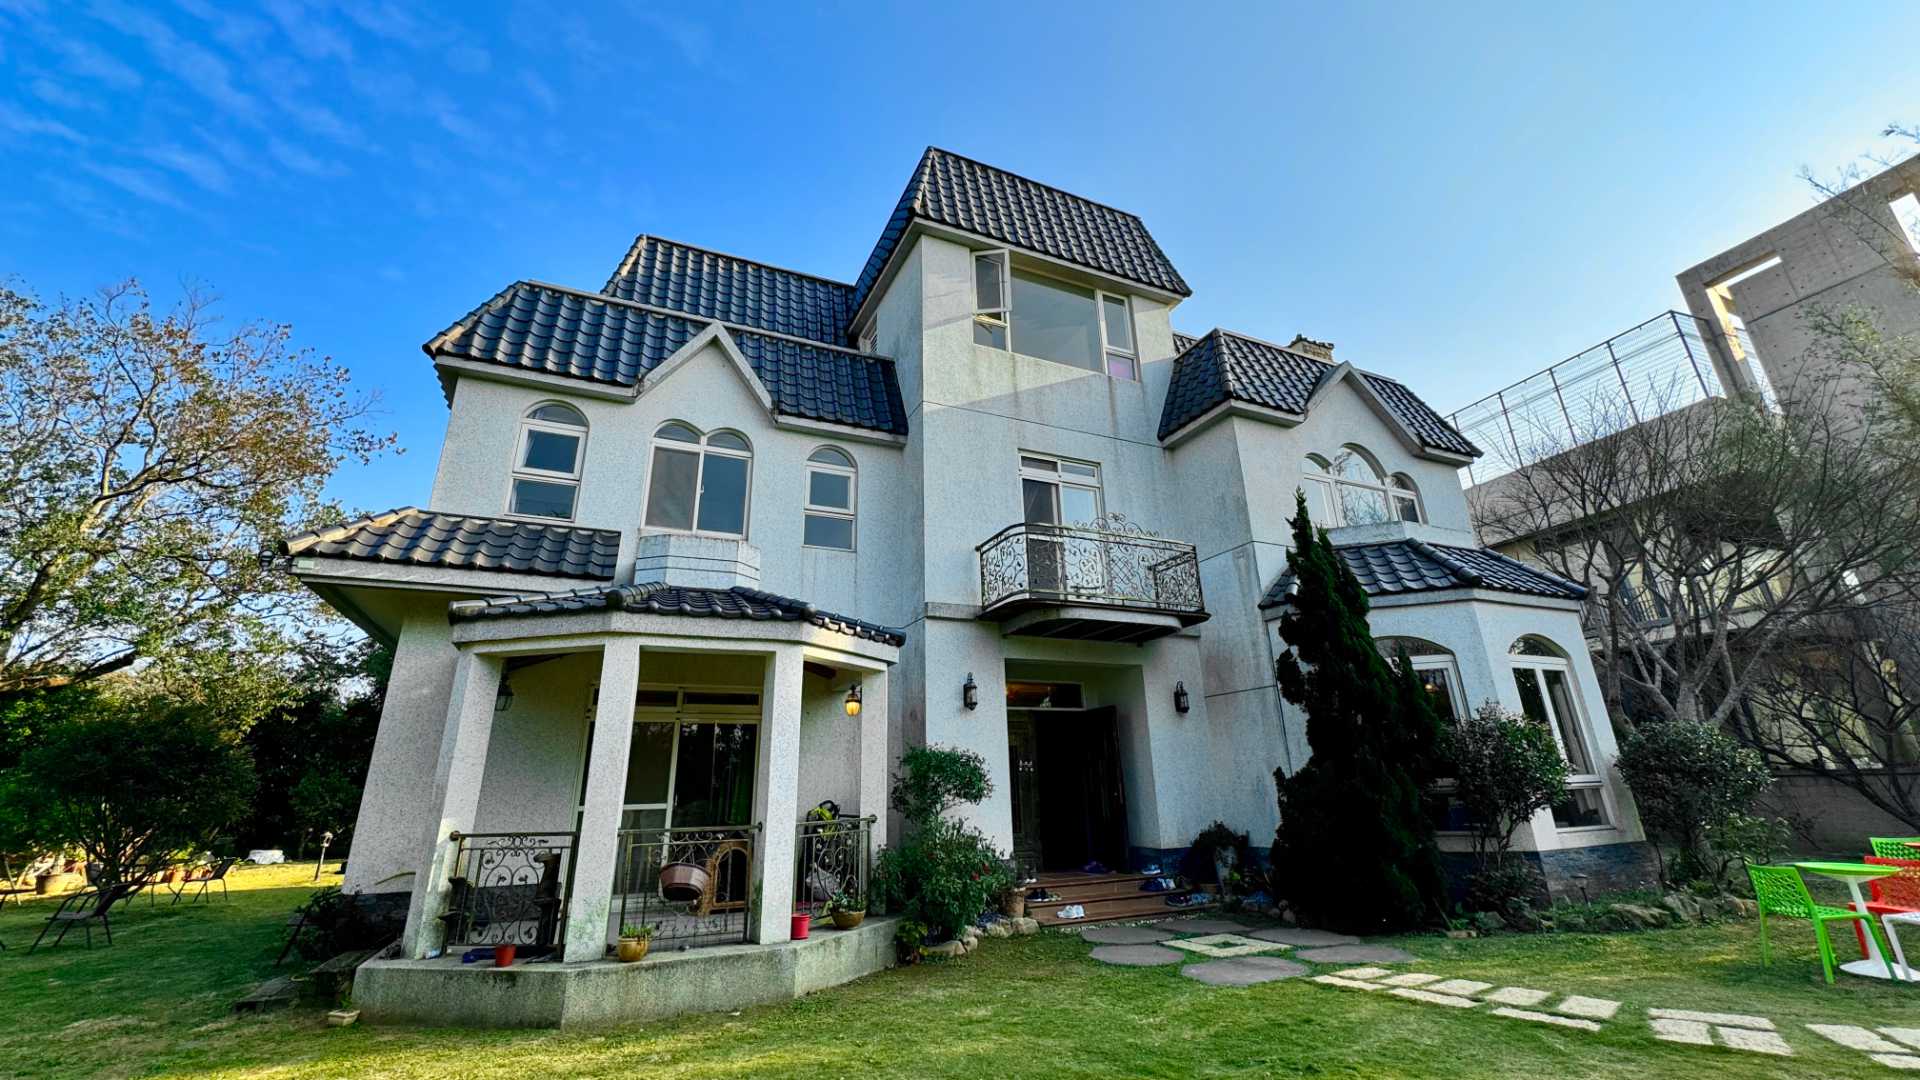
[612, 824, 760, 949]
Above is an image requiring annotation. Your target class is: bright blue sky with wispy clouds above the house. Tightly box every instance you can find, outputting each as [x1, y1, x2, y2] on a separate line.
[0, 0, 1920, 509]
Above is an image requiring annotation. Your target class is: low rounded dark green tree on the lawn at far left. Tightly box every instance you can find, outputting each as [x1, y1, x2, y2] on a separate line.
[0, 694, 255, 882]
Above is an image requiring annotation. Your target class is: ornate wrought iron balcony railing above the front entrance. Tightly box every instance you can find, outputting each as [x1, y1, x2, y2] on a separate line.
[977, 515, 1206, 615]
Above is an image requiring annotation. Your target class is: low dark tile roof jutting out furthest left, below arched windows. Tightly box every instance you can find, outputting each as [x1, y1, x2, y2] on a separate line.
[280, 505, 620, 578]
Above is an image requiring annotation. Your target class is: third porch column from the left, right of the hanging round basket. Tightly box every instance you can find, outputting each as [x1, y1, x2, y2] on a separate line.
[751, 646, 803, 944]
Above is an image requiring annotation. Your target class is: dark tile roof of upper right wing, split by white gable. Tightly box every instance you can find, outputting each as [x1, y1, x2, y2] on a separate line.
[1160, 329, 1480, 455]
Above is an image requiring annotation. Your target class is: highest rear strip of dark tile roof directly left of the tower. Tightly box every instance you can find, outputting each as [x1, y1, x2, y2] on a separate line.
[601, 236, 852, 346]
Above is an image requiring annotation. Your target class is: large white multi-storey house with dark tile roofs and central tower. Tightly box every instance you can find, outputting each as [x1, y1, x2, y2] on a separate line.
[286, 150, 1644, 1019]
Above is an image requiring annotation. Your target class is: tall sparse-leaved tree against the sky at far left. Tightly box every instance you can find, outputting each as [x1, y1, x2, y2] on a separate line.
[0, 282, 392, 694]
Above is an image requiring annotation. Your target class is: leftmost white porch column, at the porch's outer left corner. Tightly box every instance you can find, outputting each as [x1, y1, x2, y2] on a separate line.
[401, 651, 503, 959]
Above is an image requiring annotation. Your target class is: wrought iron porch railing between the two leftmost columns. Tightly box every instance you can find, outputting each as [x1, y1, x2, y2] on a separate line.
[440, 832, 580, 945]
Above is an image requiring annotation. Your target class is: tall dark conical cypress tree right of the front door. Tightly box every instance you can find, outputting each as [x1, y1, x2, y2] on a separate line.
[1273, 496, 1444, 932]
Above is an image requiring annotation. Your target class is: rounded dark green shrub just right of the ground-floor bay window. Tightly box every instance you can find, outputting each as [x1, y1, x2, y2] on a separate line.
[1620, 721, 1772, 880]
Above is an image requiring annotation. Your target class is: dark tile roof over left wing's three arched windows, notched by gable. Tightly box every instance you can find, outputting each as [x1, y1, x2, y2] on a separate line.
[422, 281, 906, 434]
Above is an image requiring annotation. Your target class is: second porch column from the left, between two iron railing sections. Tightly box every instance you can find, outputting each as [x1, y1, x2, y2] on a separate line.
[561, 638, 639, 963]
